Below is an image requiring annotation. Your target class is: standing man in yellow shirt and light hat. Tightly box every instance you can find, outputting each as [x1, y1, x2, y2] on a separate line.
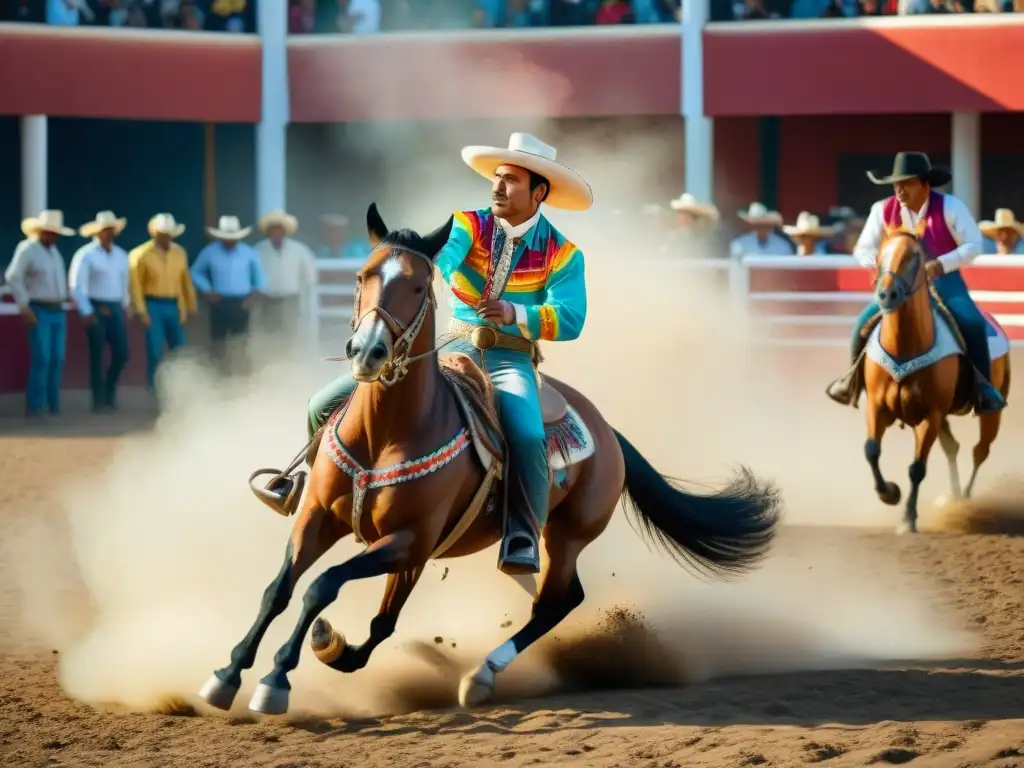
[128, 213, 196, 389]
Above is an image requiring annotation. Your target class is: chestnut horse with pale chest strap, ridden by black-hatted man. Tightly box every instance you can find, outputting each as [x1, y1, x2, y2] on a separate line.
[864, 231, 1010, 532]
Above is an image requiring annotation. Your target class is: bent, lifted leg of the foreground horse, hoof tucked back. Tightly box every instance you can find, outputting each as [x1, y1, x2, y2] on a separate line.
[309, 565, 423, 672]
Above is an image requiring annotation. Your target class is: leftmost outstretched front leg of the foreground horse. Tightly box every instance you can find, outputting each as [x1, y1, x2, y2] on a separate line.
[200, 502, 350, 710]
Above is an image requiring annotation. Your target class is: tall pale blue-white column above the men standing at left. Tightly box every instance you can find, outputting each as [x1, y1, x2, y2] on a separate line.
[256, 0, 290, 216]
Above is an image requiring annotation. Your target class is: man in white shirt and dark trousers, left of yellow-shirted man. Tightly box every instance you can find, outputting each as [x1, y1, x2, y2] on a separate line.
[69, 211, 130, 413]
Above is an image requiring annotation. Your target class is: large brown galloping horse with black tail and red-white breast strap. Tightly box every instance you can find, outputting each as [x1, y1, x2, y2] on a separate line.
[200, 206, 779, 714]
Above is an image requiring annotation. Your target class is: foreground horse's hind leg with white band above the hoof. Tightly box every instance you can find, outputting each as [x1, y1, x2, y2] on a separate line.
[459, 528, 584, 707]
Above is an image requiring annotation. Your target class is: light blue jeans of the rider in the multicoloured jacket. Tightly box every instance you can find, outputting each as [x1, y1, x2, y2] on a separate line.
[307, 341, 549, 527]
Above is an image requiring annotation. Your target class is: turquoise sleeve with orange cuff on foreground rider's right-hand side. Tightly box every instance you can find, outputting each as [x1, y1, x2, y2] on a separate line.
[512, 242, 587, 341]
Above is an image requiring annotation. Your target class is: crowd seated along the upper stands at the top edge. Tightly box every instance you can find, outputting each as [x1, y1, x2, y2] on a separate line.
[8, 0, 1024, 35]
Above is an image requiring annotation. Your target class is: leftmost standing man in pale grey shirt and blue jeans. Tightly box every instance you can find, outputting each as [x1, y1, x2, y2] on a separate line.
[4, 211, 75, 418]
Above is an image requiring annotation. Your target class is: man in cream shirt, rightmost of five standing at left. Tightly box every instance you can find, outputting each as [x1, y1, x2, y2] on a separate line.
[256, 211, 316, 340]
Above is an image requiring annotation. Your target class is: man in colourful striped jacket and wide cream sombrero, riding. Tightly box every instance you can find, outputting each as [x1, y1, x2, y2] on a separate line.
[257, 133, 593, 573]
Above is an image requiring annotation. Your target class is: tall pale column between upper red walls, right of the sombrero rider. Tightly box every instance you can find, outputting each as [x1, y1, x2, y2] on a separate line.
[680, 0, 715, 202]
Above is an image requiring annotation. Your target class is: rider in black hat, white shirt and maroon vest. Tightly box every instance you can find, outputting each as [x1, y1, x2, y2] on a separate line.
[826, 152, 1007, 414]
